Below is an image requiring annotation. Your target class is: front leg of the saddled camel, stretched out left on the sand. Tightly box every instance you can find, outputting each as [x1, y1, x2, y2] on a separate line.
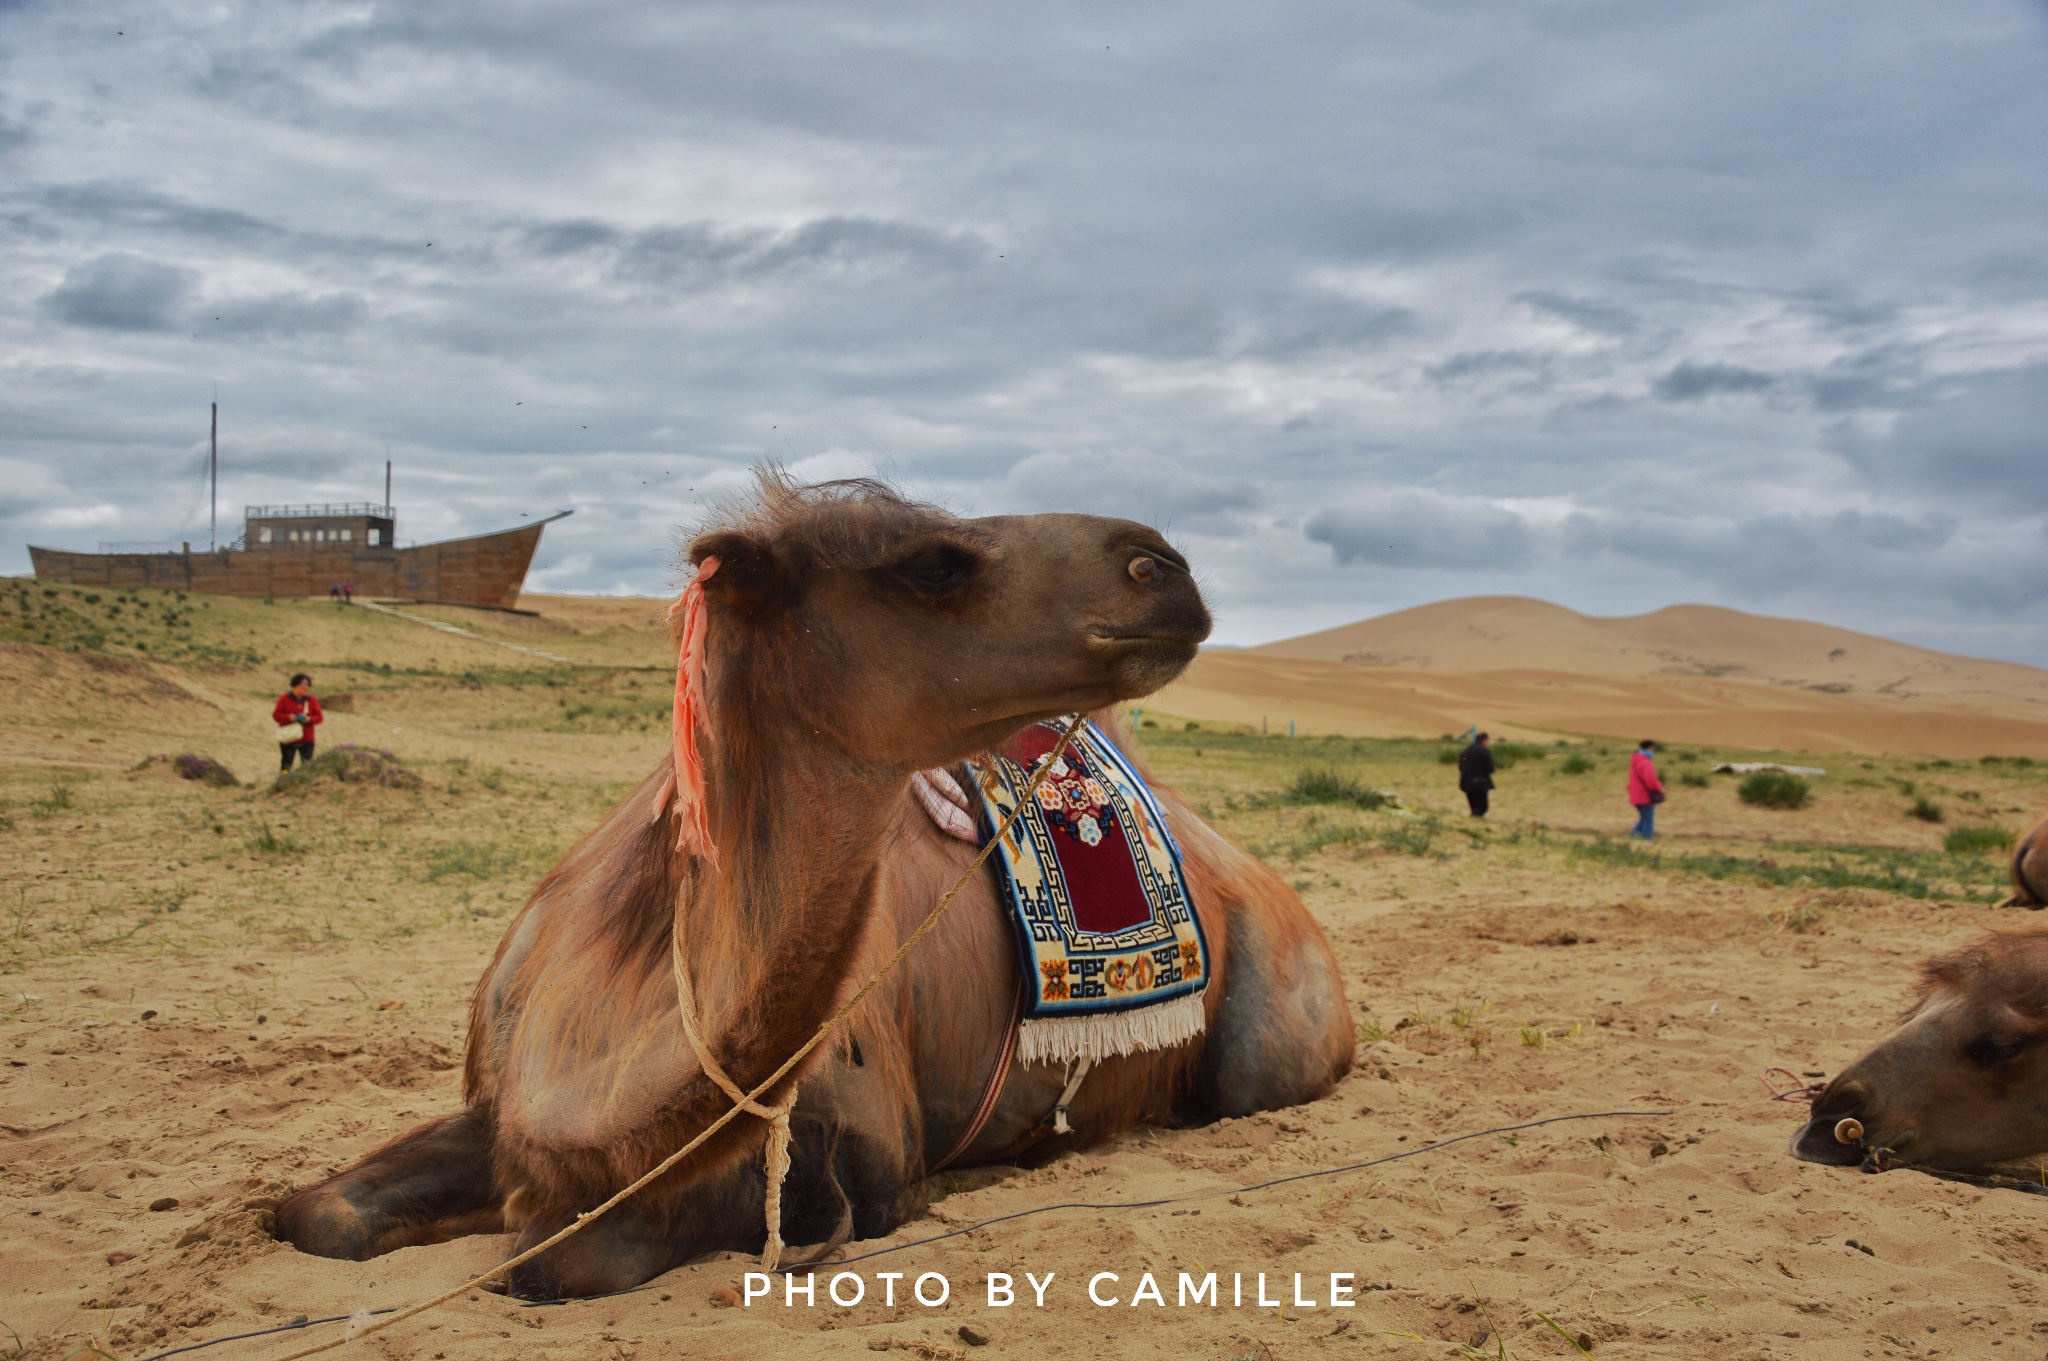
[276, 1105, 504, 1261]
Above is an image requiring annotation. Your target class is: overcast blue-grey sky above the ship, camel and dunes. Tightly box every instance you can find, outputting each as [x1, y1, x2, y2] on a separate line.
[0, 0, 2048, 663]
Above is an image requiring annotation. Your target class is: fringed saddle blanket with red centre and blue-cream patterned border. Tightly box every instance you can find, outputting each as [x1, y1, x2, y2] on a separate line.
[969, 722, 1208, 1062]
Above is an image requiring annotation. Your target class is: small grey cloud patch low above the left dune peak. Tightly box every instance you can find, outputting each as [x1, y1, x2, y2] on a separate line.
[1303, 491, 1536, 569]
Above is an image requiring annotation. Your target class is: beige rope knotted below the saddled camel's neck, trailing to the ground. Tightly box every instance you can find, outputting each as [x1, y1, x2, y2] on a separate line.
[276, 714, 1085, 1361]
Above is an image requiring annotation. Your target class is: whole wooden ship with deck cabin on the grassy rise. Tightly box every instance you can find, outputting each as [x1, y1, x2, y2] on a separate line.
[29, 501, 569, 610]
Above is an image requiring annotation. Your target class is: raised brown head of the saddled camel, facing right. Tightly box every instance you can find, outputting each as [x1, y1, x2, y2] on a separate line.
[688, 473, 1208, 774]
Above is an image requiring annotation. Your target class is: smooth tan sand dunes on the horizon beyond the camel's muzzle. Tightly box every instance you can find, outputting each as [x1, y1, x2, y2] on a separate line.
[1153, 596, 2048, 759]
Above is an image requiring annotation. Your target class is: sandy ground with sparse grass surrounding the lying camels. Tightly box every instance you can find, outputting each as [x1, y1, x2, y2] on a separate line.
[0, 596, 2048, 1361]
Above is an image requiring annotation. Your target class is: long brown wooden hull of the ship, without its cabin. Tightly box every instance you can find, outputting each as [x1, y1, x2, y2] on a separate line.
[29, 520, 547, 610]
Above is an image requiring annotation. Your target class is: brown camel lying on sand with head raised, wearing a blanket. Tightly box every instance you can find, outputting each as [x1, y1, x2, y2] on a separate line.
[279, 477, 1354, 1298]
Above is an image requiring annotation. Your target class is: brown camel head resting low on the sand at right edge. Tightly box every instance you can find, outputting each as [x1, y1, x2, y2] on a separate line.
[1790, 931, 2048, 1171]
